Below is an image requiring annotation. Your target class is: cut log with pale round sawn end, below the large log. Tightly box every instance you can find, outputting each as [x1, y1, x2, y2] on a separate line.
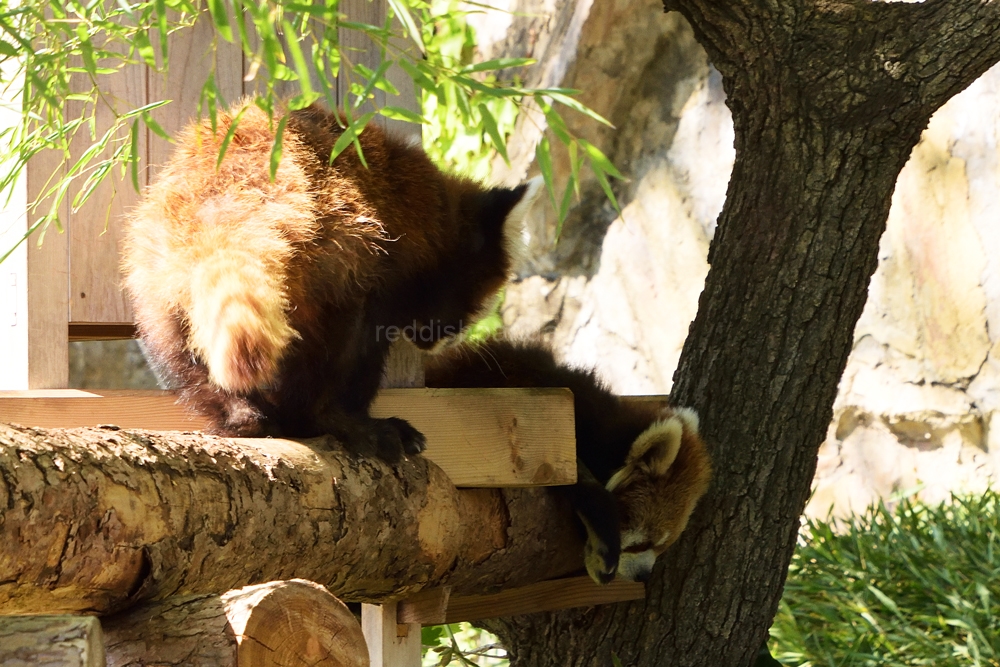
[103, 579, 369, 667]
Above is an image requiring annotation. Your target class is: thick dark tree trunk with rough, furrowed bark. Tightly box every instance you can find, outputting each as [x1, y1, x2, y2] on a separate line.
[486, 0, 1000, 667]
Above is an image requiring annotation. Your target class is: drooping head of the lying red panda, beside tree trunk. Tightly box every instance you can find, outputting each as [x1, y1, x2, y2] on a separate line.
[606, 408, 712, 581]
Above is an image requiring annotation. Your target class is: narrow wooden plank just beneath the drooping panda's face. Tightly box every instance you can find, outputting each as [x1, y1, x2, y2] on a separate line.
[397, 577, 646, 625]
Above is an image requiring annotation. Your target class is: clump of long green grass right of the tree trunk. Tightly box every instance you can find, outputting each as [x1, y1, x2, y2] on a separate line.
[771, 491, 1000, 667]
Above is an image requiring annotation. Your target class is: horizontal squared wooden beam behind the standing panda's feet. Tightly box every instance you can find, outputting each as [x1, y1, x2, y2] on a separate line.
[0, 389, 576, 487]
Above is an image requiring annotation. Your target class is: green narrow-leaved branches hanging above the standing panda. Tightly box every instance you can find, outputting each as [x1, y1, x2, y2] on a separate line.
[0, 0, 621, 261]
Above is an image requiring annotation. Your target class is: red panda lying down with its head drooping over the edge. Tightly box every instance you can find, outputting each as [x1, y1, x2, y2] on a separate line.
[425, 339, 712, 583]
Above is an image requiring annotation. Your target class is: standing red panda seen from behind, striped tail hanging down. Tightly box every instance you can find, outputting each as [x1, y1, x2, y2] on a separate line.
[123, 101, 539, 461]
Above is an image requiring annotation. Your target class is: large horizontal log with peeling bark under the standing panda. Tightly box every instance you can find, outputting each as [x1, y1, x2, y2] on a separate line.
[0, 425, 583, 615]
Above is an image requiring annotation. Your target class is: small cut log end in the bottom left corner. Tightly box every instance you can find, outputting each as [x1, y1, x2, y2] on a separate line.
[0, 616, 104, 667]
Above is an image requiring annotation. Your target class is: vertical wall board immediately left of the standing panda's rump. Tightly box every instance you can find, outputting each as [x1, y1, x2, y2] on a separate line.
[67, 60, 146, 322]
